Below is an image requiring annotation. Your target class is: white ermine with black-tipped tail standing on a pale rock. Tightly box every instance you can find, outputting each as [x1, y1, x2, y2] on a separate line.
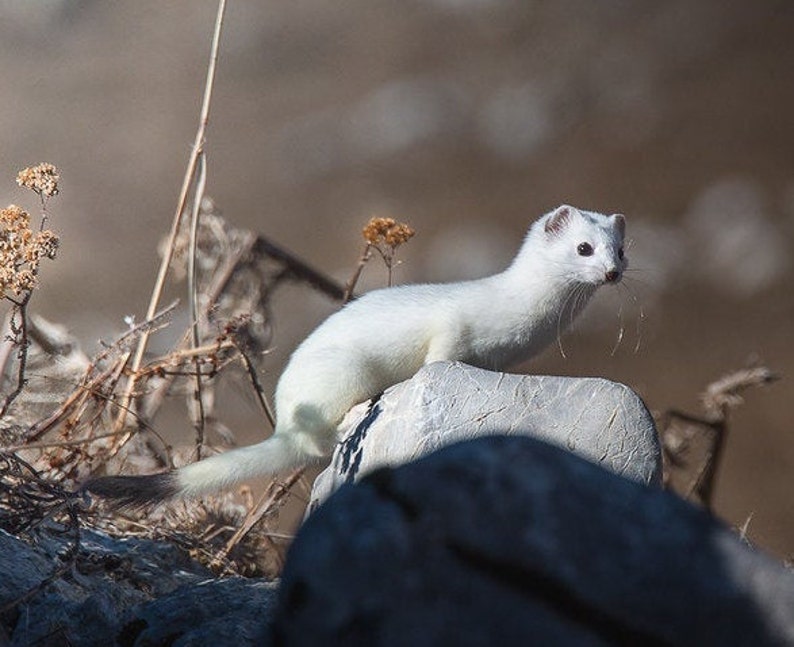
[85, 205, 627, 506]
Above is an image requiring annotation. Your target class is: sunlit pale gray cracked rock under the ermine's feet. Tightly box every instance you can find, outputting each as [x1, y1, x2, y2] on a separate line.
[310, 362, 662, 509]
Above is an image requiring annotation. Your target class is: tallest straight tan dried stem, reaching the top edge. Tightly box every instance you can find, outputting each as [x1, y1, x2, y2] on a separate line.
[114, 0, 226, 436]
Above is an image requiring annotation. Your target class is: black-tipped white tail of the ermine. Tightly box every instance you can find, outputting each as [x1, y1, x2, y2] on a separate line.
[83, 434, 311, 507]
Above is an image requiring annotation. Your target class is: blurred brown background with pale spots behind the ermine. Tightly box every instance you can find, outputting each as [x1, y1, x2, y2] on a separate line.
[0, 0, 794, 556]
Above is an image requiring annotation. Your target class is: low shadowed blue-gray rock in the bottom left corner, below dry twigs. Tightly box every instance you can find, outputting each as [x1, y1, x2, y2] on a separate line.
[0, 526, 275, 647]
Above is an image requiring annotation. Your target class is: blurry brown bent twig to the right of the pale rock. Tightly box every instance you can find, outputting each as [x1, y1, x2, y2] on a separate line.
[659, 366, 778, 509]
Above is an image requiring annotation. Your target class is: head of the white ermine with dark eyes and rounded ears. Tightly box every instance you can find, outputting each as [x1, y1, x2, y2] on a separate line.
[530, 205, 628, 286]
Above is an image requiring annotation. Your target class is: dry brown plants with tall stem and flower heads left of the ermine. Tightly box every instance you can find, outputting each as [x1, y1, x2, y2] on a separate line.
[0, 0, 413, 577]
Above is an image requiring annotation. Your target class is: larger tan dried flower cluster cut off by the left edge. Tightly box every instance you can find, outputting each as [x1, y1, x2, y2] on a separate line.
[0, 204, 58, 297]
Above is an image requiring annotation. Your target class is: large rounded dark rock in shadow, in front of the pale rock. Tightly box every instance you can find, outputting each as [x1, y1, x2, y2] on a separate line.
[274, 437, 794, 647]
